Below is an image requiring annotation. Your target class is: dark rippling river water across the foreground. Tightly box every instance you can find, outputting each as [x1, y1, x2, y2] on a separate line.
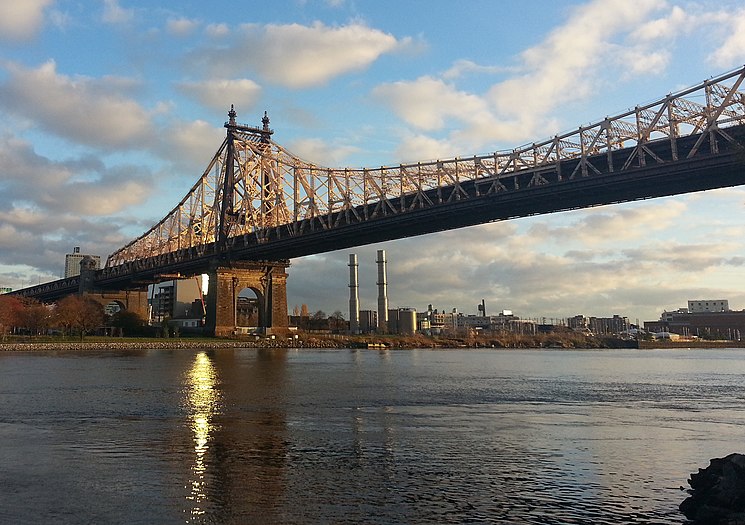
[0, 349, 745, 525]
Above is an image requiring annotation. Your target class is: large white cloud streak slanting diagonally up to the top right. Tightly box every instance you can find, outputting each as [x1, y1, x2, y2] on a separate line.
[373, 0, 681, 157]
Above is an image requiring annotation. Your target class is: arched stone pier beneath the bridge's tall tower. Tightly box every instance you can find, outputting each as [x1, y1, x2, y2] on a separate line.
[206, 261, 290, 337]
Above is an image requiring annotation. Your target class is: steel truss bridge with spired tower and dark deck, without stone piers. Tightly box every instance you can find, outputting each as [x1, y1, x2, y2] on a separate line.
[13, 67, 745, 298]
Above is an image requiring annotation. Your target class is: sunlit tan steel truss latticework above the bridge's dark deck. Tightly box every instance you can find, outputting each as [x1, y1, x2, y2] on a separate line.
[106, 67, 745, 267]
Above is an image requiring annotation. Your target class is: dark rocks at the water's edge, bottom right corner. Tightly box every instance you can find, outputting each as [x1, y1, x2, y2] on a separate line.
[680, 454, 745, 525]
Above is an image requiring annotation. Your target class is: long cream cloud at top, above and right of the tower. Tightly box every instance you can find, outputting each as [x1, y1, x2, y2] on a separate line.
[189, 22, 406, 89]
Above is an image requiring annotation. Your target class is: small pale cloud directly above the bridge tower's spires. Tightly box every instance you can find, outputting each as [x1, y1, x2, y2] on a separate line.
[176, 78, 261, 112]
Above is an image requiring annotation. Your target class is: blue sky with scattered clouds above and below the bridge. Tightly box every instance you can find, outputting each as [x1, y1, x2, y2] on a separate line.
[0, 0, 745, 322]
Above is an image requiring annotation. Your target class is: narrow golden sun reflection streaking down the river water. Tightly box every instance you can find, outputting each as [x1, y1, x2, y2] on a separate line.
[186, 352, 220, 523]
